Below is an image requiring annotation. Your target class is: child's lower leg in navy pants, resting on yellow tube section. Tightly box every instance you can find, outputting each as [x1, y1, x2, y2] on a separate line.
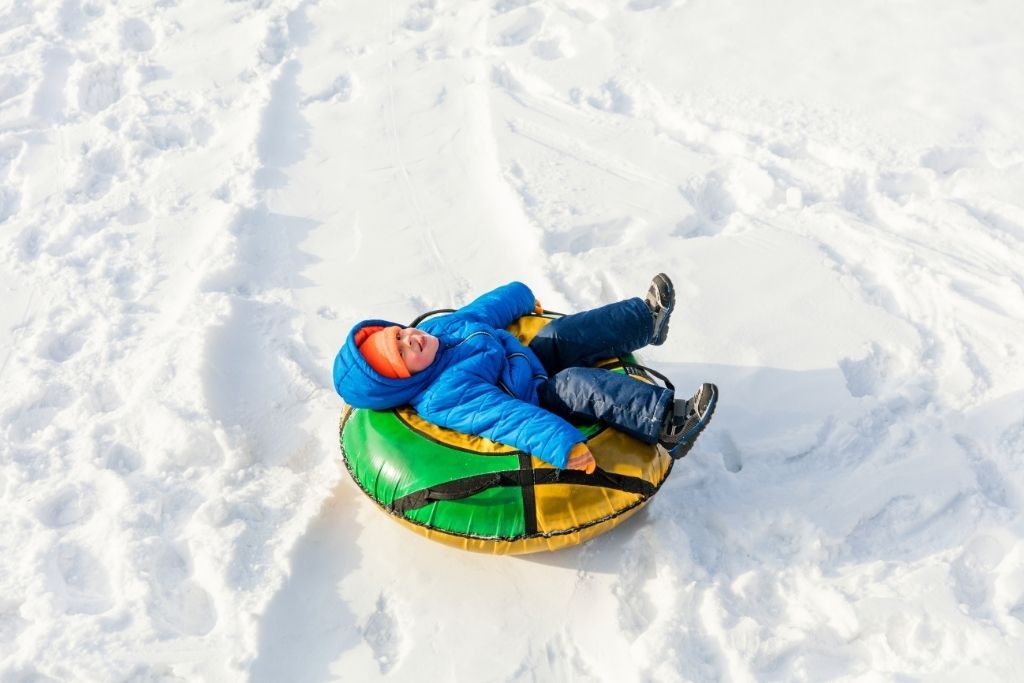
[538, 368, 674, 443]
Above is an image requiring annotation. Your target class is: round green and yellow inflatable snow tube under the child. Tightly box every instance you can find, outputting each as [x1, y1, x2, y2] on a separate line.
[340, 315, 674, 554]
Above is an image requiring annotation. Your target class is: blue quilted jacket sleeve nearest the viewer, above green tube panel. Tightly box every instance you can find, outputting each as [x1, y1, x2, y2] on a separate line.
[416, 371, 587, 469]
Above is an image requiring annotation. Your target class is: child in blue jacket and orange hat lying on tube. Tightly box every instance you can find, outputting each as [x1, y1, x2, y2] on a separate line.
[334, 273, 718, 474]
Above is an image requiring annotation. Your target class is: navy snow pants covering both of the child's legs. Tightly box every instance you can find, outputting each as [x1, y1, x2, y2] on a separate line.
[529, 297, 674, 443]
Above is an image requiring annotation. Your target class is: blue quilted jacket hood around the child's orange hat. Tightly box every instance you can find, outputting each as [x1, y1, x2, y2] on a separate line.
[334, 319, 441, 411]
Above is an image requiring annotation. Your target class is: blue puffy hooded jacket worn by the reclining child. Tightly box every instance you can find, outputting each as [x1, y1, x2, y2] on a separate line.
[334, 283, 586, 468]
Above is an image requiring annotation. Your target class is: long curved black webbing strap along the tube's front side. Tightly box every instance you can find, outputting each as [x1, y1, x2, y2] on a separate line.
[388, 468, 657, 514]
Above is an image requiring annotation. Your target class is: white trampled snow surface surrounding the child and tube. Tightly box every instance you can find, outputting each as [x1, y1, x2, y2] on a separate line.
[0, 0, 1024, 682]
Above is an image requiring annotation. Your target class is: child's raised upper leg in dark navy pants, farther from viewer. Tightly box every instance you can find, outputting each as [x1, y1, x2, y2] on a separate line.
[529, 297, 654, 374]
